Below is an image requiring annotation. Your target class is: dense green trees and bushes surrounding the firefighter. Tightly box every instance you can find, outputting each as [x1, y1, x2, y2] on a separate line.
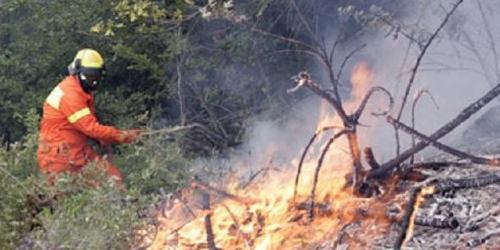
[0, 0, 406, 249]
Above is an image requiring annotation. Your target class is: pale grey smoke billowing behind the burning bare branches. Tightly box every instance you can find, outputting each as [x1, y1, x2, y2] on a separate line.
[196, 0, 500, 180]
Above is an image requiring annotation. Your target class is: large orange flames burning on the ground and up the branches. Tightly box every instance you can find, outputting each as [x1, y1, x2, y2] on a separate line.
[142, 63, 387, 249]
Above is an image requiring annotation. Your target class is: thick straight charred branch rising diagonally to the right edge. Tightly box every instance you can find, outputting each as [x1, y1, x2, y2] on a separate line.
[367, 84, 500, 178]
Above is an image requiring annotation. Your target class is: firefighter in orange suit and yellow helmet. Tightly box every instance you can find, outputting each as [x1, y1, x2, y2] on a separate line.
[38, 49, 140, 183]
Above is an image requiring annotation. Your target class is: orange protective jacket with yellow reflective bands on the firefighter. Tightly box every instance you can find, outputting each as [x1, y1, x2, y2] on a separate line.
[38, 75, 122, 179]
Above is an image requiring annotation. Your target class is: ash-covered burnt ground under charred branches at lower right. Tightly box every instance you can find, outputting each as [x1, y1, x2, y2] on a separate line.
[312, 160, 500, 249]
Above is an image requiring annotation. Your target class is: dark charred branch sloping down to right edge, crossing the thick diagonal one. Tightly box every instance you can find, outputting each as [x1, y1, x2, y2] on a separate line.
[386, 116, 500, 166]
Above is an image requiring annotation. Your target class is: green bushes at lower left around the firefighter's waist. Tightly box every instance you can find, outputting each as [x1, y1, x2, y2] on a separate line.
[0, 110, 190, 249]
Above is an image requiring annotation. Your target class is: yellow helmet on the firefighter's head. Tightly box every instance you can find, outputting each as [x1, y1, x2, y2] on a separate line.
[68, 49, 104, 76]
